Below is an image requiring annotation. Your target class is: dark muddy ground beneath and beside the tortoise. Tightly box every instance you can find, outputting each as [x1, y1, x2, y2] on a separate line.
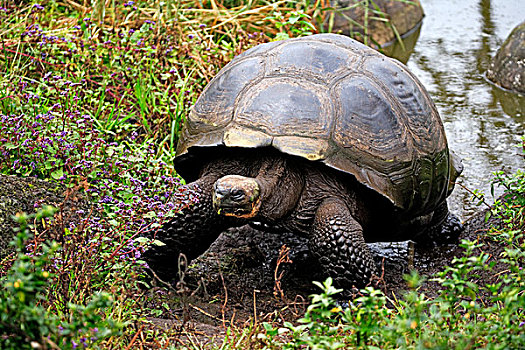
[143, 208, 503, 343]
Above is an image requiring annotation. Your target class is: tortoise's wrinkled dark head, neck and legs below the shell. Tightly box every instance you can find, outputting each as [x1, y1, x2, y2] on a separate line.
[146, 152, 458, 289]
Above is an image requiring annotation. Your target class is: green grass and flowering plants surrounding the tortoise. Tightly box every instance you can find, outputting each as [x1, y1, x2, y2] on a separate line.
[0, 0, 525, 349]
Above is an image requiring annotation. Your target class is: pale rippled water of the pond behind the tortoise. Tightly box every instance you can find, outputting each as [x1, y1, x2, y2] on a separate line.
[388, 0, 525, 219]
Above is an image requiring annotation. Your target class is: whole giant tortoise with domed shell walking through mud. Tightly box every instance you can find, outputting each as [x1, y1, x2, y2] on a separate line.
[146, 34, 461, 288]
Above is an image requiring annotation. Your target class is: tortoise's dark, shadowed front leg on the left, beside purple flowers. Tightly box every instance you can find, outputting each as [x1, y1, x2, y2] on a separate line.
[144, 175, 233, 280]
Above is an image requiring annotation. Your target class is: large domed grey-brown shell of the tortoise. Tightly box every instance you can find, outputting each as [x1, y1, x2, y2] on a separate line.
[175, 34, 455, 213]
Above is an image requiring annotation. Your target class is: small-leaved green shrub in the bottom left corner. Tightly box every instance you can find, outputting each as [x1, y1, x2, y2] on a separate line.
[0, 208, 124, 350]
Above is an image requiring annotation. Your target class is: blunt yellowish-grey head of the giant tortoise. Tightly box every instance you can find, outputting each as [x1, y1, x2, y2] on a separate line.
[212, 175, 261, 218]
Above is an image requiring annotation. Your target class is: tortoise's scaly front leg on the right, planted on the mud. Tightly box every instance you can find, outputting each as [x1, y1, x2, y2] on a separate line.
[309, 199, 376, 290]
